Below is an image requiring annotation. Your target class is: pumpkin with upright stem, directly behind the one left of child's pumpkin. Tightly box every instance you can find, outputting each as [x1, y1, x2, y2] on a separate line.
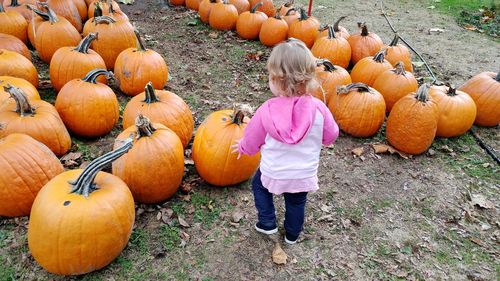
[123, 85, 194, 147]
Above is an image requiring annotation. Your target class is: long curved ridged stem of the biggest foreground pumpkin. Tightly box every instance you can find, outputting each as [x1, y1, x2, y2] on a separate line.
[69, 137, 134, 198]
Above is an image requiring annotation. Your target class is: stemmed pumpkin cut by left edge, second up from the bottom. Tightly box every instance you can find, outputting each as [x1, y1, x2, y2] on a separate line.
[0, 85, 71, 156]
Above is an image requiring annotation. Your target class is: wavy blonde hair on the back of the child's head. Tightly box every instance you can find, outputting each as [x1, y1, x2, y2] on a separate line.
[267, 38, 316, 97]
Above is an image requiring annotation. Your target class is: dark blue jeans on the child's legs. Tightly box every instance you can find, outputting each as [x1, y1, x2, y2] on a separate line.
[252, 169, 307, 237]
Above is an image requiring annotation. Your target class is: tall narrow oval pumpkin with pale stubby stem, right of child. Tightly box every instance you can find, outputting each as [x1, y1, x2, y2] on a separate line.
[385, 84, 439, 154]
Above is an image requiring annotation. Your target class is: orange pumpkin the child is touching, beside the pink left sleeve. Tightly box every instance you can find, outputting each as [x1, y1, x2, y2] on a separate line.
[192, 110, 260, 186]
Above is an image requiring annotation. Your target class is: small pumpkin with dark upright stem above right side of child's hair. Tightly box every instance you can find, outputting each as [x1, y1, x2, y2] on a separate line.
[288, 9, 320, 49]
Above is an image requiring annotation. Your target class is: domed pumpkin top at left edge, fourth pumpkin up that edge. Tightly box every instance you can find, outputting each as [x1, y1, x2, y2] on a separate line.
[0, 49, 38, 87]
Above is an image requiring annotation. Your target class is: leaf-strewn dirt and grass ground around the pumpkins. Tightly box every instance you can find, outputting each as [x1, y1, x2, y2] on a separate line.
[0, 0, 500, 280]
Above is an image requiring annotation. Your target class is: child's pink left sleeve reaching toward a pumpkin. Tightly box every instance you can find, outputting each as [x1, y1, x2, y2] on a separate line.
[238, 108, 267, 155]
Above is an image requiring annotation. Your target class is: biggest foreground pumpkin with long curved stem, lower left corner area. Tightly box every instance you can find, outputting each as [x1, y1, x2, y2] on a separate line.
[28, 139, 135, 275]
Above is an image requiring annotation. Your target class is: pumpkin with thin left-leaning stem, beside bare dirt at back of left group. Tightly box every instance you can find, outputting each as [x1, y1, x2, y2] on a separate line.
[114, 30, 168, 96]
